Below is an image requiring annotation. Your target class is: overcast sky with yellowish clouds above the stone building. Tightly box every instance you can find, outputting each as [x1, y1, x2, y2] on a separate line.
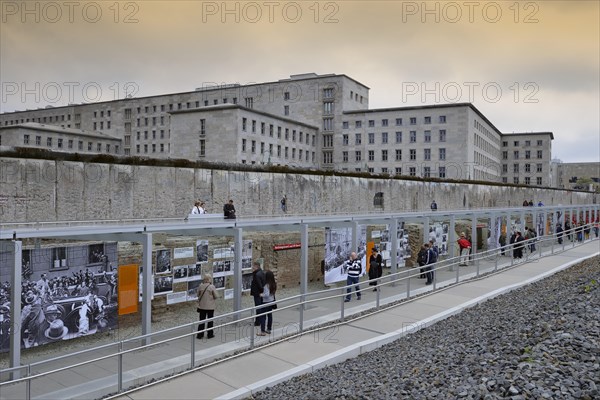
[0, 0, 600, 162]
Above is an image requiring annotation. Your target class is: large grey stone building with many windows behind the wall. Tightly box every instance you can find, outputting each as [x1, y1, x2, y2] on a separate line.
[0, 73, 553, 186]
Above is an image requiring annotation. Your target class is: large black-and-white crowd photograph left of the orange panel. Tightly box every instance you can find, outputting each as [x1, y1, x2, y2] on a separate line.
[0, 242, 118, 352]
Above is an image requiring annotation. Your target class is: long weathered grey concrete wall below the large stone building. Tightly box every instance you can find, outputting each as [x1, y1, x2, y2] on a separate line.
[0, 158, 598, 222]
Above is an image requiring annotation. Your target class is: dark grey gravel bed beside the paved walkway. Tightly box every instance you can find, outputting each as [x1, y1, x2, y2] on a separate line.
[251, 257, 600, 400]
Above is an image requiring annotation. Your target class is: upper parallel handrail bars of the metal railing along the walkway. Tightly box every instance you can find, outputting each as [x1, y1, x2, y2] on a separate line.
[0, 222, 598, 398]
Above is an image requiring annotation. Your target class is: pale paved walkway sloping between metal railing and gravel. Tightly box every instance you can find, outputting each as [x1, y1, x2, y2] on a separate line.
[108, 240, 600, 400]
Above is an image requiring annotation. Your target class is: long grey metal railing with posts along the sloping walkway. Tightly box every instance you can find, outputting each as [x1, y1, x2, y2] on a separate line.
[0, 223, 599, 400]
